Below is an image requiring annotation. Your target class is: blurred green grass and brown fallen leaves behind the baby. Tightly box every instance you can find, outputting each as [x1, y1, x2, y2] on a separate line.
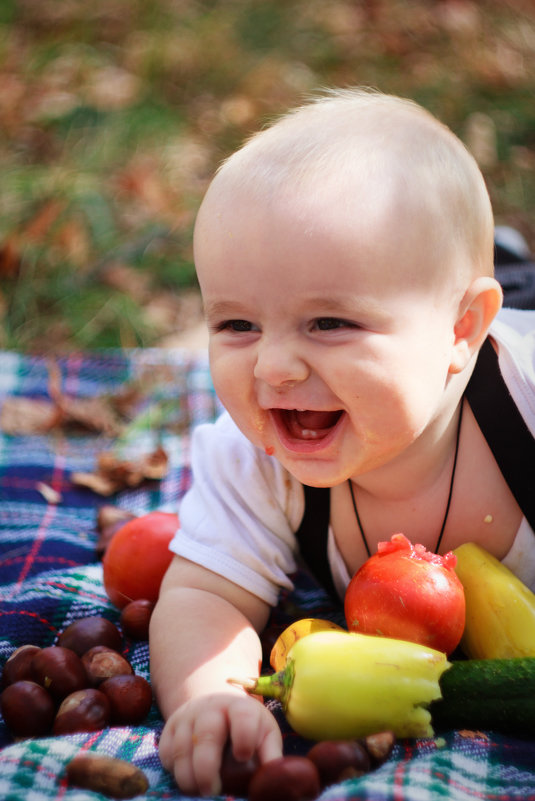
[0, 0, 535, 352]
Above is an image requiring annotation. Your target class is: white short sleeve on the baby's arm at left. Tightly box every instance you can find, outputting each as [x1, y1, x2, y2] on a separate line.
[170, 412, 304, 606]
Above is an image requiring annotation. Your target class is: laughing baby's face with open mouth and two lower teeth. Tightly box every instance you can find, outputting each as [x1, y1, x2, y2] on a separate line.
[195, 177, 464, 486]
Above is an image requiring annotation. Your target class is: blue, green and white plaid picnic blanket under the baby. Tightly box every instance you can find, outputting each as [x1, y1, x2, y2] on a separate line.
[0, 350, 535, 801]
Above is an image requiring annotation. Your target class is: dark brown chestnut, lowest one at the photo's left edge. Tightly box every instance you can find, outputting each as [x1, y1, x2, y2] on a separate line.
[0, 680, 56, 737]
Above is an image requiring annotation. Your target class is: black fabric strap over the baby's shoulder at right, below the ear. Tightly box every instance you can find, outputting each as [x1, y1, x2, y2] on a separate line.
[466, 339, 535, 529]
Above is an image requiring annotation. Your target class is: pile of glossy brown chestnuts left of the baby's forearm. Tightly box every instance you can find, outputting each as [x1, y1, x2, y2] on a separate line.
[0, 600, 153, 737]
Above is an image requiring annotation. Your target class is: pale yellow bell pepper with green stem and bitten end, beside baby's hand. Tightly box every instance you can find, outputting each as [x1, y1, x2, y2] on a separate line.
[229, 631, 450, 740]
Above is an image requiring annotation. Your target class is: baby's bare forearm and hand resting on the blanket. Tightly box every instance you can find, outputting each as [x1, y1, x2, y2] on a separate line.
[150, 557, 282, 795]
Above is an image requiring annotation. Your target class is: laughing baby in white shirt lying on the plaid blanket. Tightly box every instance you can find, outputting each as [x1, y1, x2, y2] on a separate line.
[150, 89, 535, 795]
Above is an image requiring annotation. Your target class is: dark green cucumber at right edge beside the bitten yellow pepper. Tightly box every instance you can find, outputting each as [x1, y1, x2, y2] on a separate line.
[429, 657, 535, 737]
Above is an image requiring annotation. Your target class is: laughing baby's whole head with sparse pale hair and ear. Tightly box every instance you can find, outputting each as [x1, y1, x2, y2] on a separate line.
[195, 90, 501, 486]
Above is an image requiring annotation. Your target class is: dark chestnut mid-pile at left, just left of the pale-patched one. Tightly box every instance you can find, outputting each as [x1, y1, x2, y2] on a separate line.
[32, 645, 87, 701]
